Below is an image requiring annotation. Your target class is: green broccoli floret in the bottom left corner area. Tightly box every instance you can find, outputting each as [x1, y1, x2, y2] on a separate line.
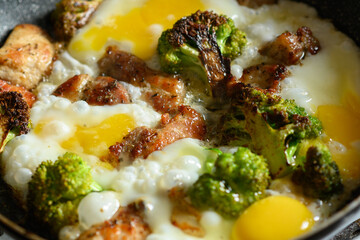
[27, 153, 102, 233]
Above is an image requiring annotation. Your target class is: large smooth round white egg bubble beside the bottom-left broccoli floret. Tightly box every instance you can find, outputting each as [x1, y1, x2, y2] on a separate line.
[78, 191, 120, 229]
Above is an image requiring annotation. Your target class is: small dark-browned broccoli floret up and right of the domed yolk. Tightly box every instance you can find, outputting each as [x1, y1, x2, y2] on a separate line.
[292, 139, 343, 200]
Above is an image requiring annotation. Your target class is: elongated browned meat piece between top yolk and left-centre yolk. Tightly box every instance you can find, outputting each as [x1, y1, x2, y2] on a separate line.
[98, 46, 185, 113]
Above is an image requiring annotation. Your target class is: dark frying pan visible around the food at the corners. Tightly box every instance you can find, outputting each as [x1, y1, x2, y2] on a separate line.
[0, 0, 360, 240]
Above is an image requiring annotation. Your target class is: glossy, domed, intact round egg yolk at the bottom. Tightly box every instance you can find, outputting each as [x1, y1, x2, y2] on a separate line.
[232, 196, 314, 240]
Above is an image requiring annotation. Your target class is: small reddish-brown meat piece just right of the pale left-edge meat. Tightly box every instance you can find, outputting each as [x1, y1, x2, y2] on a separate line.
[53, 74, 92, 102]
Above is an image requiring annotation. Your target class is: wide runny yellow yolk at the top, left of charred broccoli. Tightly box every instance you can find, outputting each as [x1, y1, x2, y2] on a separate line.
[69, 0, 204, 59]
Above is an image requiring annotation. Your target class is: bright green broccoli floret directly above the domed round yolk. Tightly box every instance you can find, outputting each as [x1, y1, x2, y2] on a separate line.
[188, 147, 270, 217]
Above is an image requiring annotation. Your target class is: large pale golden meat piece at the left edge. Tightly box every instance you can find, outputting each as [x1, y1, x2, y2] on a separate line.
[0, 24, 55, 90]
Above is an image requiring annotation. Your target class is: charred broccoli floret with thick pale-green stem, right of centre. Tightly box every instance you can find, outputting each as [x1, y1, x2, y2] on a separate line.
[224, 83, 322, 178]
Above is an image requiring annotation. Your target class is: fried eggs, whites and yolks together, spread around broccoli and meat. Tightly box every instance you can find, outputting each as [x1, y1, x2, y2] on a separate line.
[2, 0, 360, 240]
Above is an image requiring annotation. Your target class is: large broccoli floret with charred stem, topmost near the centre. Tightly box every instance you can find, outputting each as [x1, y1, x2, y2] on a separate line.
[157, 11, 246, 95]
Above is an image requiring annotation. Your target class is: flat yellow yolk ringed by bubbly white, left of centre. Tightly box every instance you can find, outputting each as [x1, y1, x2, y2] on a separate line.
[61, 114, 135, 157]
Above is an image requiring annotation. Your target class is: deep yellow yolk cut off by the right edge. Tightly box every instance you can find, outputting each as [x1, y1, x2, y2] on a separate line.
[317, 92, 360, 179]
